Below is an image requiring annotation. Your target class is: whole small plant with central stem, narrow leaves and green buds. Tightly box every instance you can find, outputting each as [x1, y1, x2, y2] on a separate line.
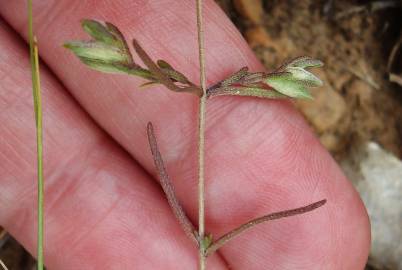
[65, 12, 326, 270]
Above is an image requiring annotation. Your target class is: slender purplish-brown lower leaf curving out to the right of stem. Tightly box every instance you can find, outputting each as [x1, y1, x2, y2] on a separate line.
[206, 200, 327, 256]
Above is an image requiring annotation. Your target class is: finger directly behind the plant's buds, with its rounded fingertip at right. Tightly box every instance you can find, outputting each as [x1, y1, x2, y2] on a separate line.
[1, 0, 368, 269]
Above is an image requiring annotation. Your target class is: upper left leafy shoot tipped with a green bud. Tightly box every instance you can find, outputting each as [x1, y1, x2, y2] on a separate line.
[64, 20, 202, 95]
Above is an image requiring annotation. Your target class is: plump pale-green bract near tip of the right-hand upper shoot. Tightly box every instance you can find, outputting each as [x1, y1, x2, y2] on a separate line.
[264, 72, 312, 99]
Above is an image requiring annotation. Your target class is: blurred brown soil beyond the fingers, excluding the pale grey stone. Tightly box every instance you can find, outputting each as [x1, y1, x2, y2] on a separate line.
[0, 0, 402, 269]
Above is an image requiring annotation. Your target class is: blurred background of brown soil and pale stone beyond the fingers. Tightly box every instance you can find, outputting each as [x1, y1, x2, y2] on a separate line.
[0, 0, 402, 270]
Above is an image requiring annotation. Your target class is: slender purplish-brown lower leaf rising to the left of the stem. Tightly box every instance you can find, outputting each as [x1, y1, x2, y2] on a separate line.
[147, 122, 198, 243]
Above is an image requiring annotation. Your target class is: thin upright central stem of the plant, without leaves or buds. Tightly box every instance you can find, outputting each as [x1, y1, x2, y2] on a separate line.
[196, 0, 207, 270]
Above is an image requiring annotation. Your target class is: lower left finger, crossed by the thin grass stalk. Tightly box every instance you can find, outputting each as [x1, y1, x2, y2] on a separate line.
[0, 20, 225, 269]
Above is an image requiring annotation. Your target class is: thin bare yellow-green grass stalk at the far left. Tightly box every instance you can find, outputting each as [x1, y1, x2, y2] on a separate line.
[28, 0, 44, 270]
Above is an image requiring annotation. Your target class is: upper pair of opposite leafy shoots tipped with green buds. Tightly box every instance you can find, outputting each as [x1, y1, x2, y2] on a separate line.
[64, 20, 323, 99]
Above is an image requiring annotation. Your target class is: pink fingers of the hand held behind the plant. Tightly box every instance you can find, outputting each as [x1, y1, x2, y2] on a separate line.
[0, 0, 370, 270]
